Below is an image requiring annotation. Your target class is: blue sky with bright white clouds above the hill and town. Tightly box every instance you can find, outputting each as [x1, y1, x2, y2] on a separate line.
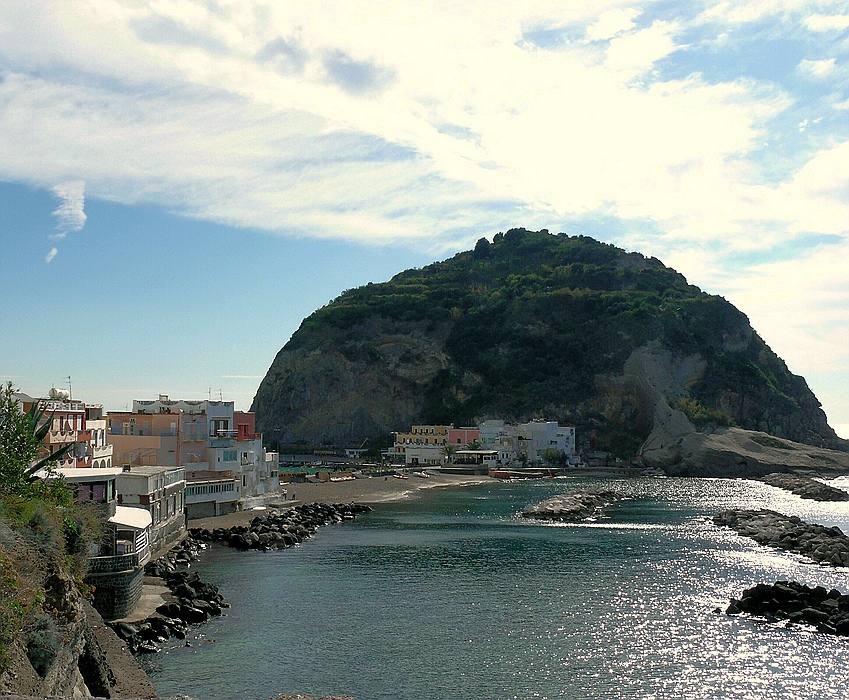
[0, 0, 849, 438]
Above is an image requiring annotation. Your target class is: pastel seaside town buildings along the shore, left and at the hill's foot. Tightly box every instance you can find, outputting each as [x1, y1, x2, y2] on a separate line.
[4, 388, 581, 621]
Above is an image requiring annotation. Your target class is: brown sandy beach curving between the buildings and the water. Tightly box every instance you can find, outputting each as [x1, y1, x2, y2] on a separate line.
[189, 474, 497, 529]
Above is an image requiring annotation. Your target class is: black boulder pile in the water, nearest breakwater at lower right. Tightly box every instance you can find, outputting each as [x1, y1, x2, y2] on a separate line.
[725, 581, 849, 636]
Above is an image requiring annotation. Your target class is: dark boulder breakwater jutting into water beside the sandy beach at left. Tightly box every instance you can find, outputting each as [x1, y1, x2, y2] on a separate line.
[194, 503, 371, 551]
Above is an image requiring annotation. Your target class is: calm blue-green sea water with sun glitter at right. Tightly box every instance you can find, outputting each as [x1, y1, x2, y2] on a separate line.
[142, 479, 849, 700]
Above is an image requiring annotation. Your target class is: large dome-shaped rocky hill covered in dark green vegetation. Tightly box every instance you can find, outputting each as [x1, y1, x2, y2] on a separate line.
[252, 229, 847, 456]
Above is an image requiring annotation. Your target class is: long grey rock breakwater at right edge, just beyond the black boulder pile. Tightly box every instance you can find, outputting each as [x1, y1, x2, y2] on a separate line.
[713, 510, 849, 566]
